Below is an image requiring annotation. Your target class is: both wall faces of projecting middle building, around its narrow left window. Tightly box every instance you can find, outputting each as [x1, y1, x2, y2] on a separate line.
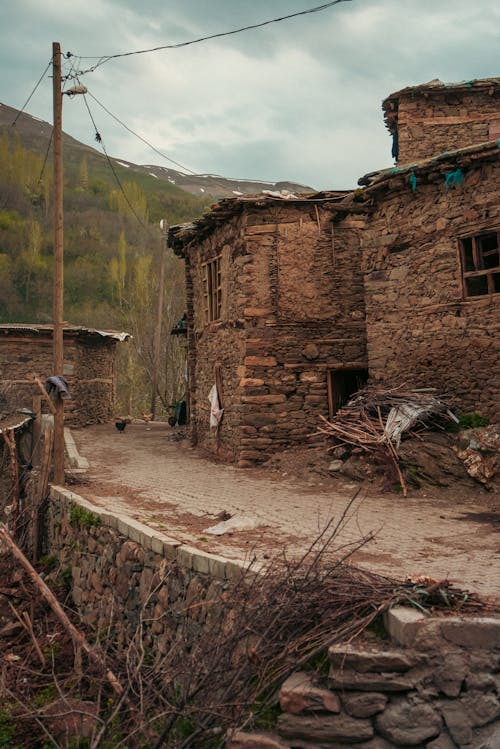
[187, 204, 366, 467]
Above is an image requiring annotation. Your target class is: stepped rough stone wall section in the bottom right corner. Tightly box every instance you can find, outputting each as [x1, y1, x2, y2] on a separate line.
[226, 608, 500, 749]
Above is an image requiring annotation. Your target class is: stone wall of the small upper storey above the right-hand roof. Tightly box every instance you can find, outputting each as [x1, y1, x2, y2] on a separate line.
[398, 87, 500, 166]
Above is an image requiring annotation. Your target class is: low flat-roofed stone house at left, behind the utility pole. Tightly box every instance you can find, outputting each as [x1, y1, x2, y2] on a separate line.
[0, 323, 129, 426]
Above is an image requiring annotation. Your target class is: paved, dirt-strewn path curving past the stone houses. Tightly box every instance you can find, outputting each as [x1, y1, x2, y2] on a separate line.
[73, 424, 500, 597]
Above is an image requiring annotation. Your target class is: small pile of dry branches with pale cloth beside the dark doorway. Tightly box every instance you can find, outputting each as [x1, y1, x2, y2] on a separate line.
[318, 386, 456, 496]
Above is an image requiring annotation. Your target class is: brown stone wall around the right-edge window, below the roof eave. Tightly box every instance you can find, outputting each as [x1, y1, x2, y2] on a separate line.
[362, 159, 500, 420]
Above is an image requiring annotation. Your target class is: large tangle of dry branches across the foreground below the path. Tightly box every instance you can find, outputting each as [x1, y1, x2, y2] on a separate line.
[0, 500, 483, 749]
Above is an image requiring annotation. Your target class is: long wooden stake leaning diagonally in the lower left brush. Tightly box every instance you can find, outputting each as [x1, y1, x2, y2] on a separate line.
[0, 523, 123, 695]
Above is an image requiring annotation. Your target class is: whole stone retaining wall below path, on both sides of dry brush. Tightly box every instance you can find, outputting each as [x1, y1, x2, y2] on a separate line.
[46, 487, 500, 749]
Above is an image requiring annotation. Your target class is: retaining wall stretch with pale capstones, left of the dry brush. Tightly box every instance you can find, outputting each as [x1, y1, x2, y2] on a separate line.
[45, 487, 249, 654]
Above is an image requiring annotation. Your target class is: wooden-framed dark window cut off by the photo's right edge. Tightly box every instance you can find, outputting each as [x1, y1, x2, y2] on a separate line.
[460, 231, 500, 297]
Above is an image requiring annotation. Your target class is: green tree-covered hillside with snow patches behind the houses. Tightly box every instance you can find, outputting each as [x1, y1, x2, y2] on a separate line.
[0, 105, 309, 415]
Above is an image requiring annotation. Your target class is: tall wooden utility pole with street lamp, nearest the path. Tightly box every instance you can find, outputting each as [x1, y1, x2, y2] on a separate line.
[52, 42, 64, 485]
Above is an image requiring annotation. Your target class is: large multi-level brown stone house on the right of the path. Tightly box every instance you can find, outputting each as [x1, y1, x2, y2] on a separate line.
[168, 79, 500, 466]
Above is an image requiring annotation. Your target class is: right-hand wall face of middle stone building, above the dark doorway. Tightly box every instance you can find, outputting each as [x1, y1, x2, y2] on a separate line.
[238, 204, 366, 467]
